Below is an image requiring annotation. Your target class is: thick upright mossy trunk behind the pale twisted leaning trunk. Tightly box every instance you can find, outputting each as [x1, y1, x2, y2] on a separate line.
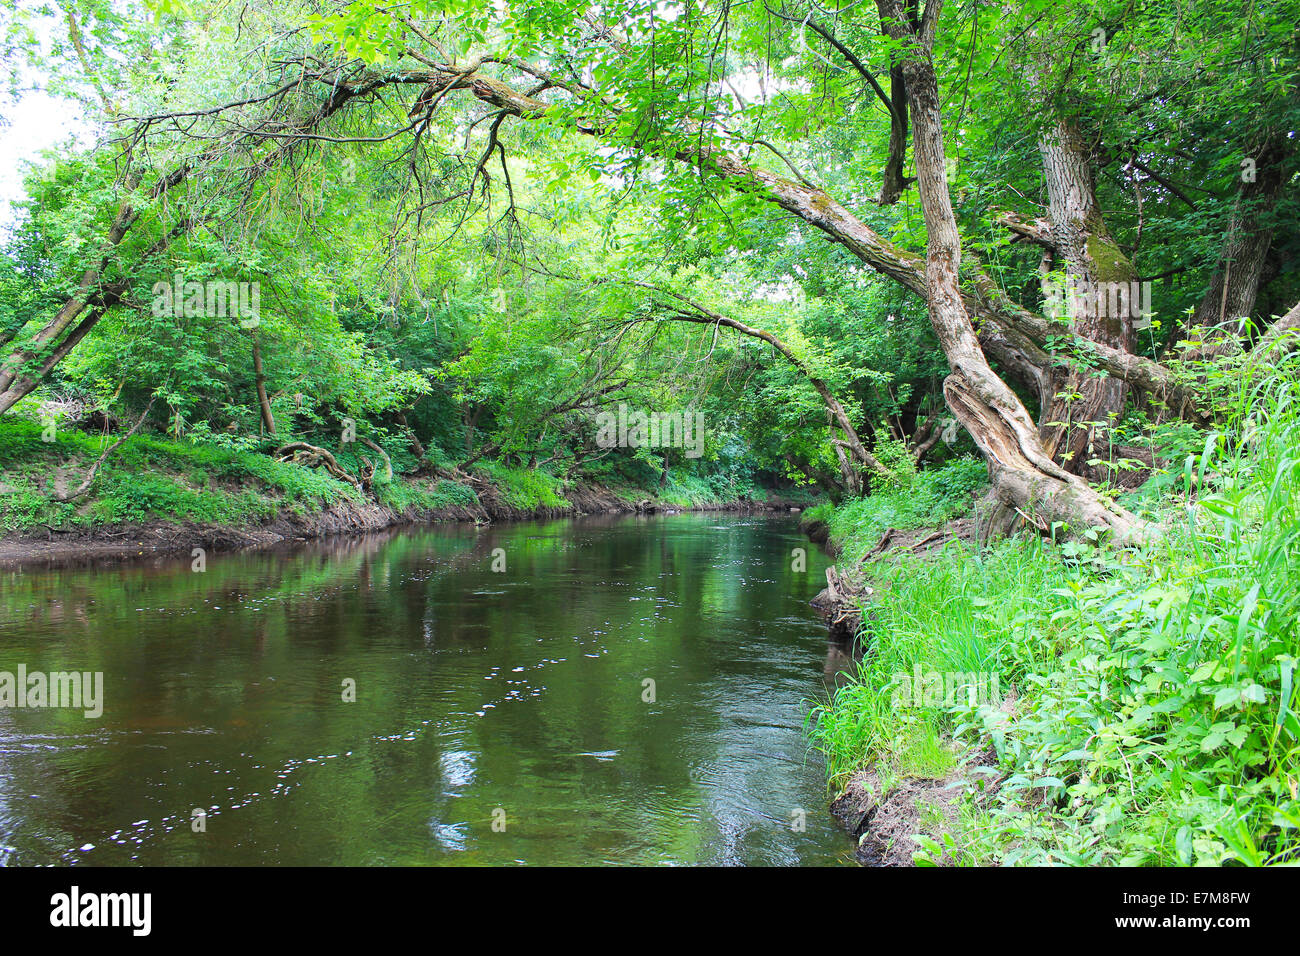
[1039, 120, 1140, 476]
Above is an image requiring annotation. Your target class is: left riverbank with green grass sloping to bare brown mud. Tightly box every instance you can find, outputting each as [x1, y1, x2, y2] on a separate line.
[0, 421, 810, 564]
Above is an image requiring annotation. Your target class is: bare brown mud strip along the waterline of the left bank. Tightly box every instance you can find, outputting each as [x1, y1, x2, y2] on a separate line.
[0, 484, 801, 567]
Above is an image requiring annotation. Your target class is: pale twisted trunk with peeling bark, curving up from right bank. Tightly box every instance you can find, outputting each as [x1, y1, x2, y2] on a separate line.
[878, 0, 1141, 538]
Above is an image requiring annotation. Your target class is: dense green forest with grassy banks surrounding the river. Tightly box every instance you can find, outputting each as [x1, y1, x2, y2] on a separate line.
[0, 0, 1300, 865]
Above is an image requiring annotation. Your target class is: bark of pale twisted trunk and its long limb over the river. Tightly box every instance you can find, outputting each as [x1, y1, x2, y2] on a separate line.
[447, 24, 1149, 540]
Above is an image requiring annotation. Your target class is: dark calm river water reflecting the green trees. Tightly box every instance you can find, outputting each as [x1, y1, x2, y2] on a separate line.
[0, 514, 852, 865]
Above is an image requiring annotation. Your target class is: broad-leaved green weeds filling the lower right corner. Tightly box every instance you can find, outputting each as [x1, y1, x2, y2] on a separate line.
[967, 373, 1300, 865]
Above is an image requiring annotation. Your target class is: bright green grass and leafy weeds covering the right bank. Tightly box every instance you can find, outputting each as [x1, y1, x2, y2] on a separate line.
[810, 366, 1300, 865]
